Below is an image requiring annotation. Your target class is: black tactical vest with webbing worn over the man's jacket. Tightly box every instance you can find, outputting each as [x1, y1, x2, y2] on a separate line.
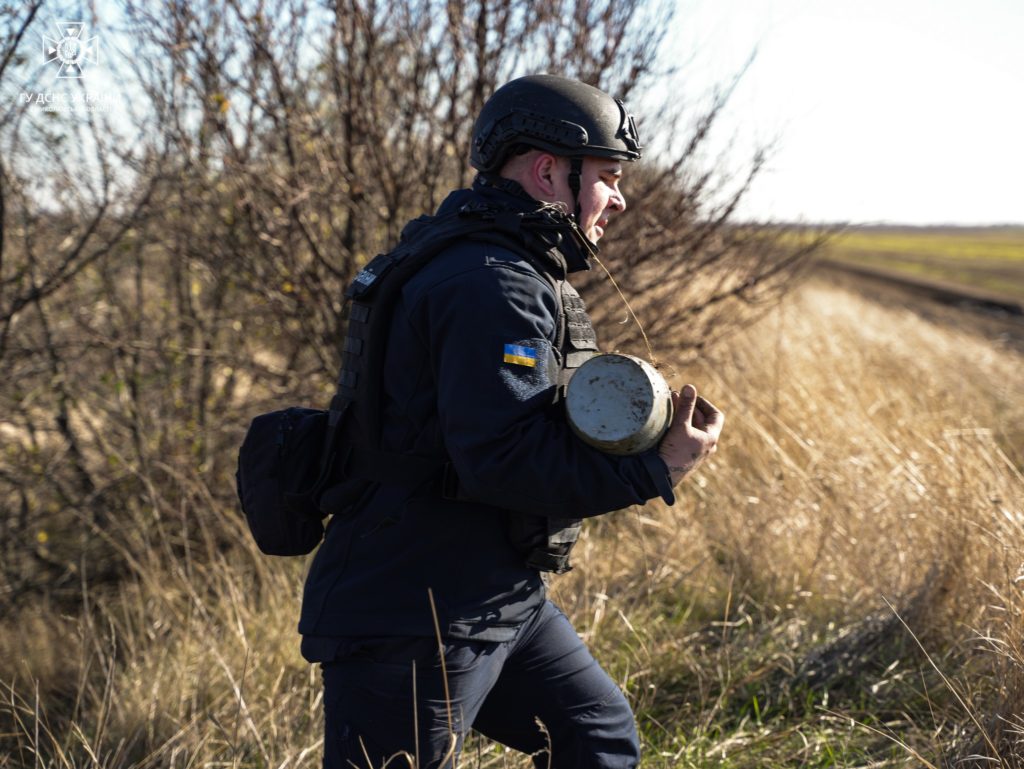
[321, 204, 597, 573]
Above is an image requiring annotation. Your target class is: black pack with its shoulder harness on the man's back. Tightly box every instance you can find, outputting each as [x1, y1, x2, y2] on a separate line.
[236, 204, 581, 555]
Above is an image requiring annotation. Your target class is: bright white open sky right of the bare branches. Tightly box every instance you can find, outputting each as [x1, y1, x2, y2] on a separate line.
[671, 0, 1024, 224]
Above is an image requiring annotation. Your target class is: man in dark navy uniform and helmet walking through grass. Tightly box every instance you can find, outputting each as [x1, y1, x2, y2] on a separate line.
[299, 75, 723, 768]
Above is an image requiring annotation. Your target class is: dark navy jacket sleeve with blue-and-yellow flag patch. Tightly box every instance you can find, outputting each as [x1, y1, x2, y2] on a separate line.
[411, 252, 675, 517]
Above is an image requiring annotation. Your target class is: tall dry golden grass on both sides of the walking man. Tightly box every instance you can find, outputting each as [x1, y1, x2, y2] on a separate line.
[0, 274, 1024, 769]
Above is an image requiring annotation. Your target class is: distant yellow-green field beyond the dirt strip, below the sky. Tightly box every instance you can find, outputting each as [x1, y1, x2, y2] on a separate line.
[823, 226, 1024, 300]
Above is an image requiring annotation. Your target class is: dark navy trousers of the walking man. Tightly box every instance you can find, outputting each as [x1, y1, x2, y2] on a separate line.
[323, 601, 640, 769]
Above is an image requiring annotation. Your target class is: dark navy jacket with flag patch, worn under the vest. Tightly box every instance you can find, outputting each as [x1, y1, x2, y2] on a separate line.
[299, 174, 673, 660]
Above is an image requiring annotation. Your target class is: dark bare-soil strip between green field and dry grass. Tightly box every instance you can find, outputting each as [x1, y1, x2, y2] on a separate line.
[816, 260, 1024, 351]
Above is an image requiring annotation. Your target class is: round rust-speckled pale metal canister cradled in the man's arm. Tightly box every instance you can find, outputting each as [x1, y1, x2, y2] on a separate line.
[565, 352, 672, 455]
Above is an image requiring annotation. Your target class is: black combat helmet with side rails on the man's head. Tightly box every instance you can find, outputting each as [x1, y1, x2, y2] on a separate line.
[470, 75, 642, 172]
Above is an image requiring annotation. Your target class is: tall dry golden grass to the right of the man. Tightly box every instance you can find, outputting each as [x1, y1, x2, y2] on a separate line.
[558, 284, 1024, 766]
